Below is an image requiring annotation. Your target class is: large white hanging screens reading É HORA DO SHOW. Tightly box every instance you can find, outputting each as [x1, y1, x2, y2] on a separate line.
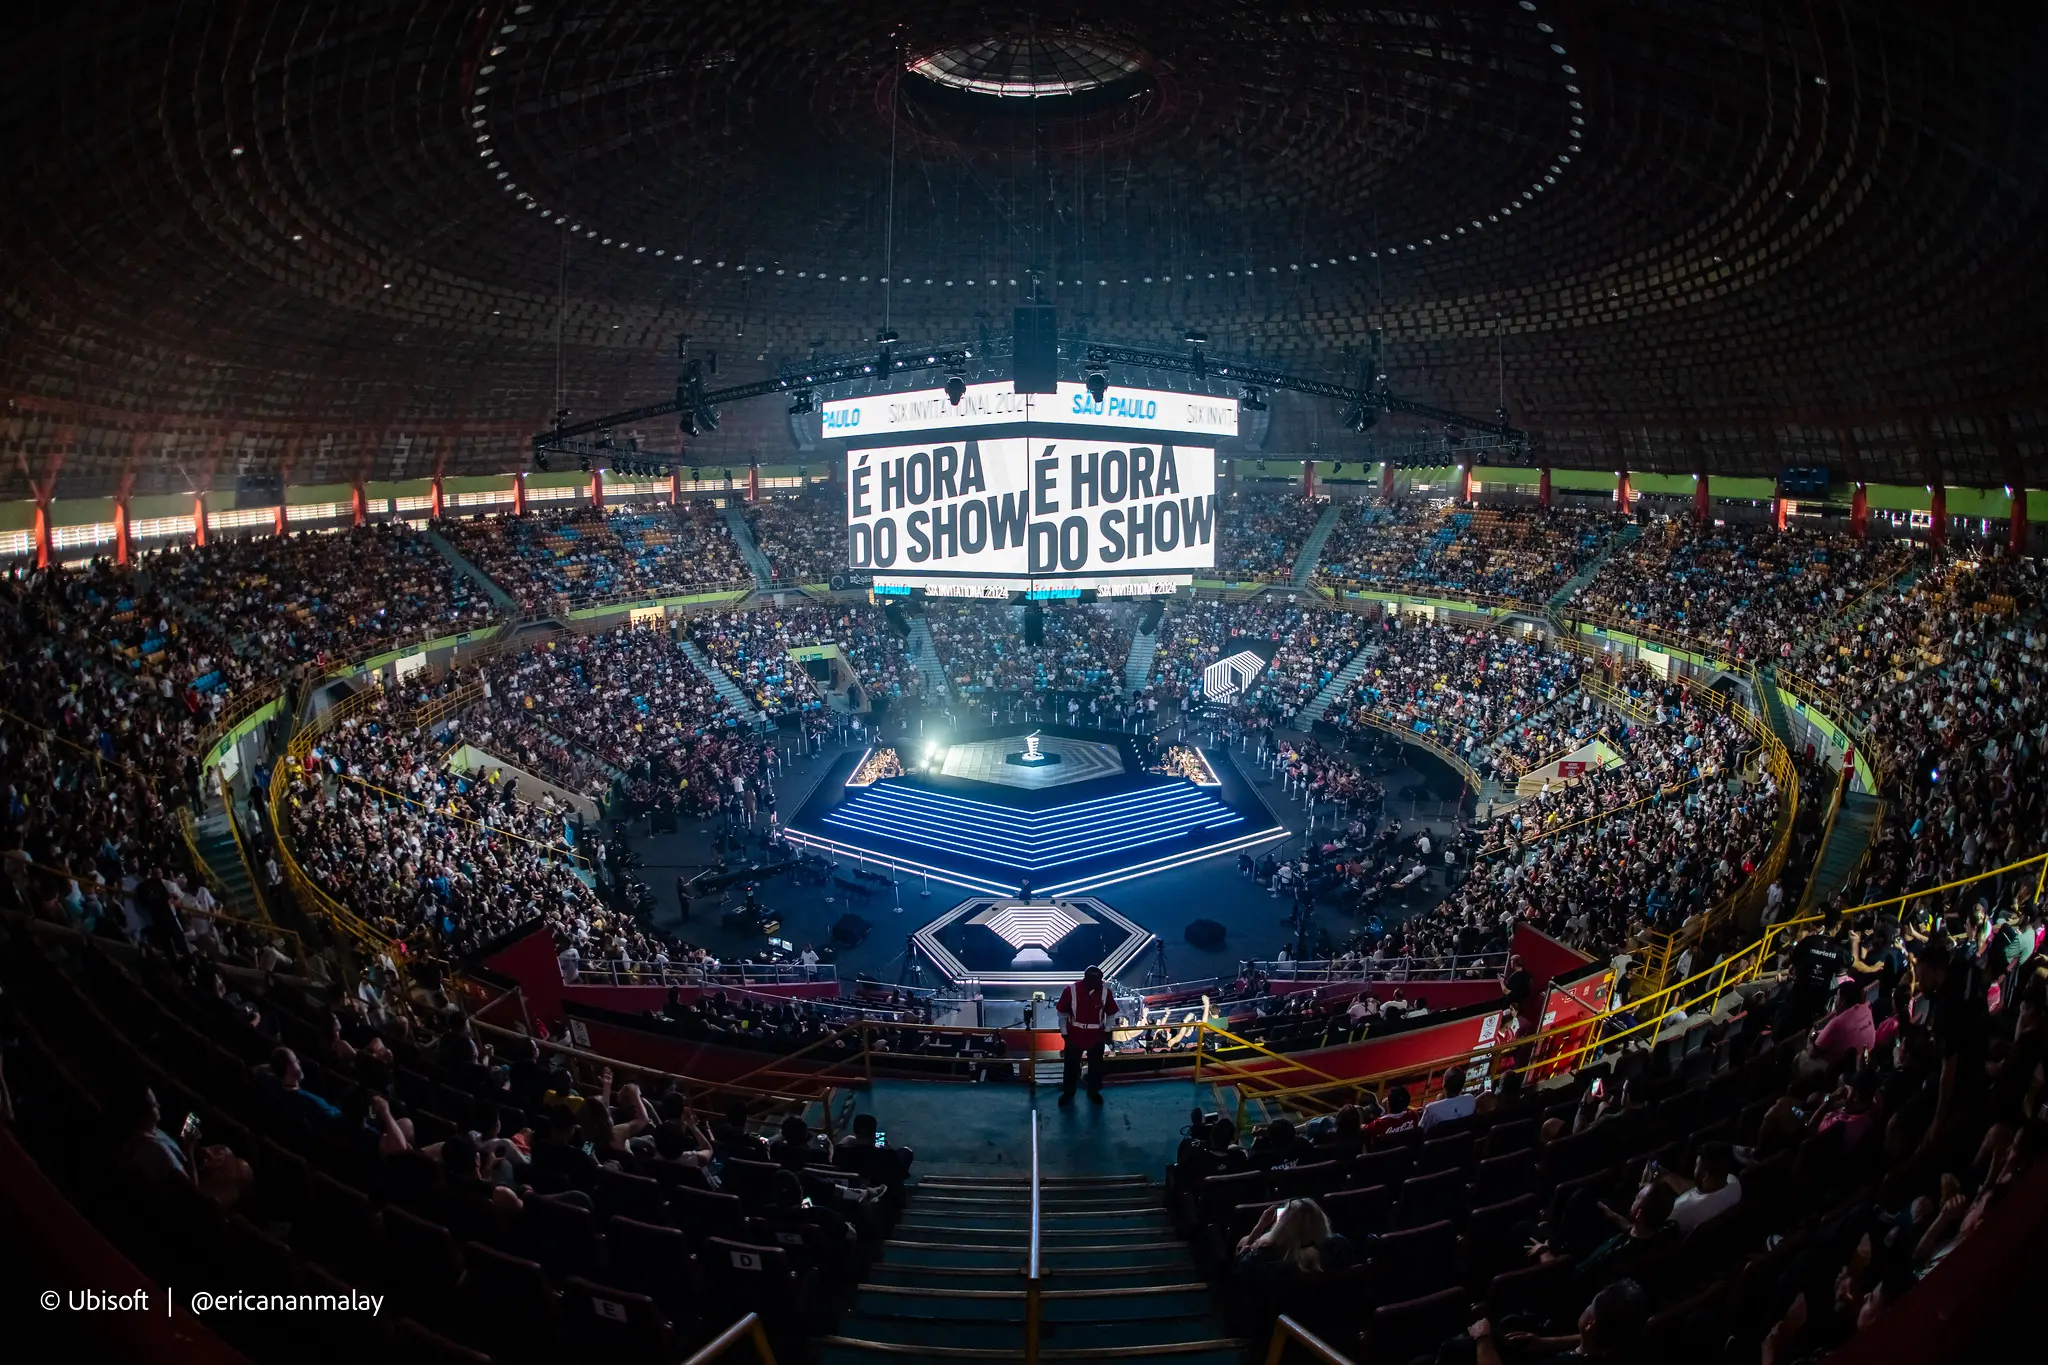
[846, 436, 1217, 581]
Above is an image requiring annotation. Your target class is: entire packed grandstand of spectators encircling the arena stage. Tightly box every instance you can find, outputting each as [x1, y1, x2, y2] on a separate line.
[0, 493, 2048, 1363]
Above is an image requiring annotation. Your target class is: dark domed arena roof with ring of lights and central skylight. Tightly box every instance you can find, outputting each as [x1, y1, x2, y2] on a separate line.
[0, 0, 2048, 497]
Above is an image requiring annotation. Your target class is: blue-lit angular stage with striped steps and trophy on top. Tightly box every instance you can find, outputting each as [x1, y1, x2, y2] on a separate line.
[784, 724, 1286, 896]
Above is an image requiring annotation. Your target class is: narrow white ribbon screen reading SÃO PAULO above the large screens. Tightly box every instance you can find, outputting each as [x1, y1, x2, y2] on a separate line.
[821, 381, 1237, 439]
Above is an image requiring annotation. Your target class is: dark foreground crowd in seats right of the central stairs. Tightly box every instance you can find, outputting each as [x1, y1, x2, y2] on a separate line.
[1167, 888, 2048, 1365]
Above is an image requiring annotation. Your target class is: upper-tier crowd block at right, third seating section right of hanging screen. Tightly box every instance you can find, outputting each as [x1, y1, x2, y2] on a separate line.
[1567, 520, 1915, 661]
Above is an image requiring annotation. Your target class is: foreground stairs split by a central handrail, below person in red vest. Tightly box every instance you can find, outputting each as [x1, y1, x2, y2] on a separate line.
[817, 1175, 1243, 1365]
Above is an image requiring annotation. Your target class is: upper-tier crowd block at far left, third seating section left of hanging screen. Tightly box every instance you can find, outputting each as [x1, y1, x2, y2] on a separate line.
[141, 522, 498, 663]
